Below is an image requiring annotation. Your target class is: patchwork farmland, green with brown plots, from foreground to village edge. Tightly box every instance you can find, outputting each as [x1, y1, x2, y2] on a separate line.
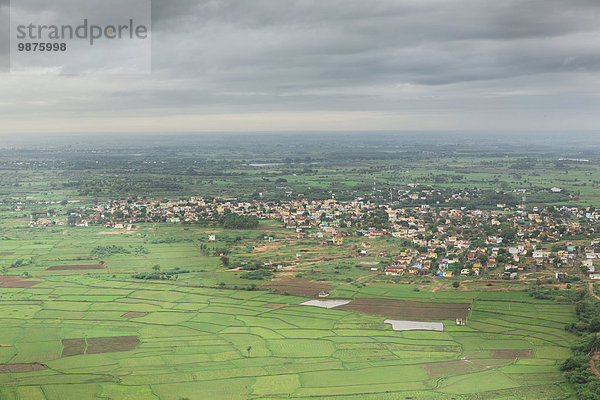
[0, 224, 576, 400]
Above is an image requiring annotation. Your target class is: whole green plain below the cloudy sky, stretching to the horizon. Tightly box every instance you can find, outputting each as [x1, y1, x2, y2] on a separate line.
[0, 134, 600, 400]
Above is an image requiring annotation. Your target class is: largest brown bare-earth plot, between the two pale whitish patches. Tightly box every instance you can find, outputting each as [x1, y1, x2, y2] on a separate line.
[336, 297, 471, 321]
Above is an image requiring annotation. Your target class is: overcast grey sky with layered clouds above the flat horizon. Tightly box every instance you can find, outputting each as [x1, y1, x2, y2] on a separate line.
[0, 0, 600, 135]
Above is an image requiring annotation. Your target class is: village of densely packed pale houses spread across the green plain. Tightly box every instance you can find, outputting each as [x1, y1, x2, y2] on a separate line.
[29, 189, 600, 281]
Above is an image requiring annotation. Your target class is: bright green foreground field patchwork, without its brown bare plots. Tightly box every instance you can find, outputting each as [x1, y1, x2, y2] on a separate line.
[0, 276, 574, 399]
